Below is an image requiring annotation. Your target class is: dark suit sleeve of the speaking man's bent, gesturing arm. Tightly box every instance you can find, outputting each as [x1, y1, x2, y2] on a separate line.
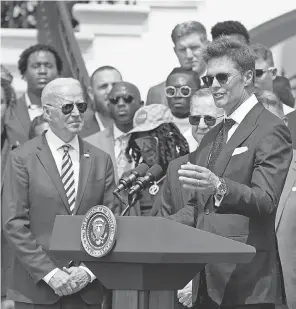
[218, 124, 293, 217]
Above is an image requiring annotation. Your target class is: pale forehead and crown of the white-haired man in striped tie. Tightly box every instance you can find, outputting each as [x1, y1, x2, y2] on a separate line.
[41, 78, 83, 106]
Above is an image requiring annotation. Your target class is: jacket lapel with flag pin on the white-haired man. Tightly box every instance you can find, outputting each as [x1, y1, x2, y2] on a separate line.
[73, 138, 92, 215]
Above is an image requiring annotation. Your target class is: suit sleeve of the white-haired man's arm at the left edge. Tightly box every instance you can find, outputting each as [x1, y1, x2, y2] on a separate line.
[2, 151, 57, 283]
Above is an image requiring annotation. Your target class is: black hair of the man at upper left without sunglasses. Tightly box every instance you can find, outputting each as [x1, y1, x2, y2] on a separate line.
[18, 44, 63, 76]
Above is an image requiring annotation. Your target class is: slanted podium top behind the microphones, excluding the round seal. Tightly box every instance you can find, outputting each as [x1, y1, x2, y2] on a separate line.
[50, 216, 255, 264]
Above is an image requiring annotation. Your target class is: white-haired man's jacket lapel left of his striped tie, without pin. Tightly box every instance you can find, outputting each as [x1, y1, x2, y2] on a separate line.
[37, 135, 71, 214]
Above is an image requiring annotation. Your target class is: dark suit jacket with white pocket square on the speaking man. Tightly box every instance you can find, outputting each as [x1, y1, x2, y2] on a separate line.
[170, 103, 292, 306]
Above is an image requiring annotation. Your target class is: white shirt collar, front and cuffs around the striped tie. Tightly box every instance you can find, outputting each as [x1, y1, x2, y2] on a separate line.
[43, 128, 96, 284]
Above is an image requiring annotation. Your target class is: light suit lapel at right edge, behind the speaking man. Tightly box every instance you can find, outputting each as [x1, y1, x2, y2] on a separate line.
[275, 150, 296, 231]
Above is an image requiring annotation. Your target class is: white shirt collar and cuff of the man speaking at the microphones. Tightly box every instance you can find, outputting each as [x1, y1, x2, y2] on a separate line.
[214, 94, 258, 207]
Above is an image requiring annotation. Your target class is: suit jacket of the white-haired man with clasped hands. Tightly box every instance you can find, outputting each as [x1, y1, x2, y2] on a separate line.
[2, 135, 115, 304]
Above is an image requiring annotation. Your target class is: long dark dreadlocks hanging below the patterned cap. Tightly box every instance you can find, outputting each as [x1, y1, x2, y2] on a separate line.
[125, 122, 189, 173]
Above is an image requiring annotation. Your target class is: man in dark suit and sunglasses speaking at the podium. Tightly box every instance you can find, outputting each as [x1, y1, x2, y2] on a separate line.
[170, 38, 292, 309]
